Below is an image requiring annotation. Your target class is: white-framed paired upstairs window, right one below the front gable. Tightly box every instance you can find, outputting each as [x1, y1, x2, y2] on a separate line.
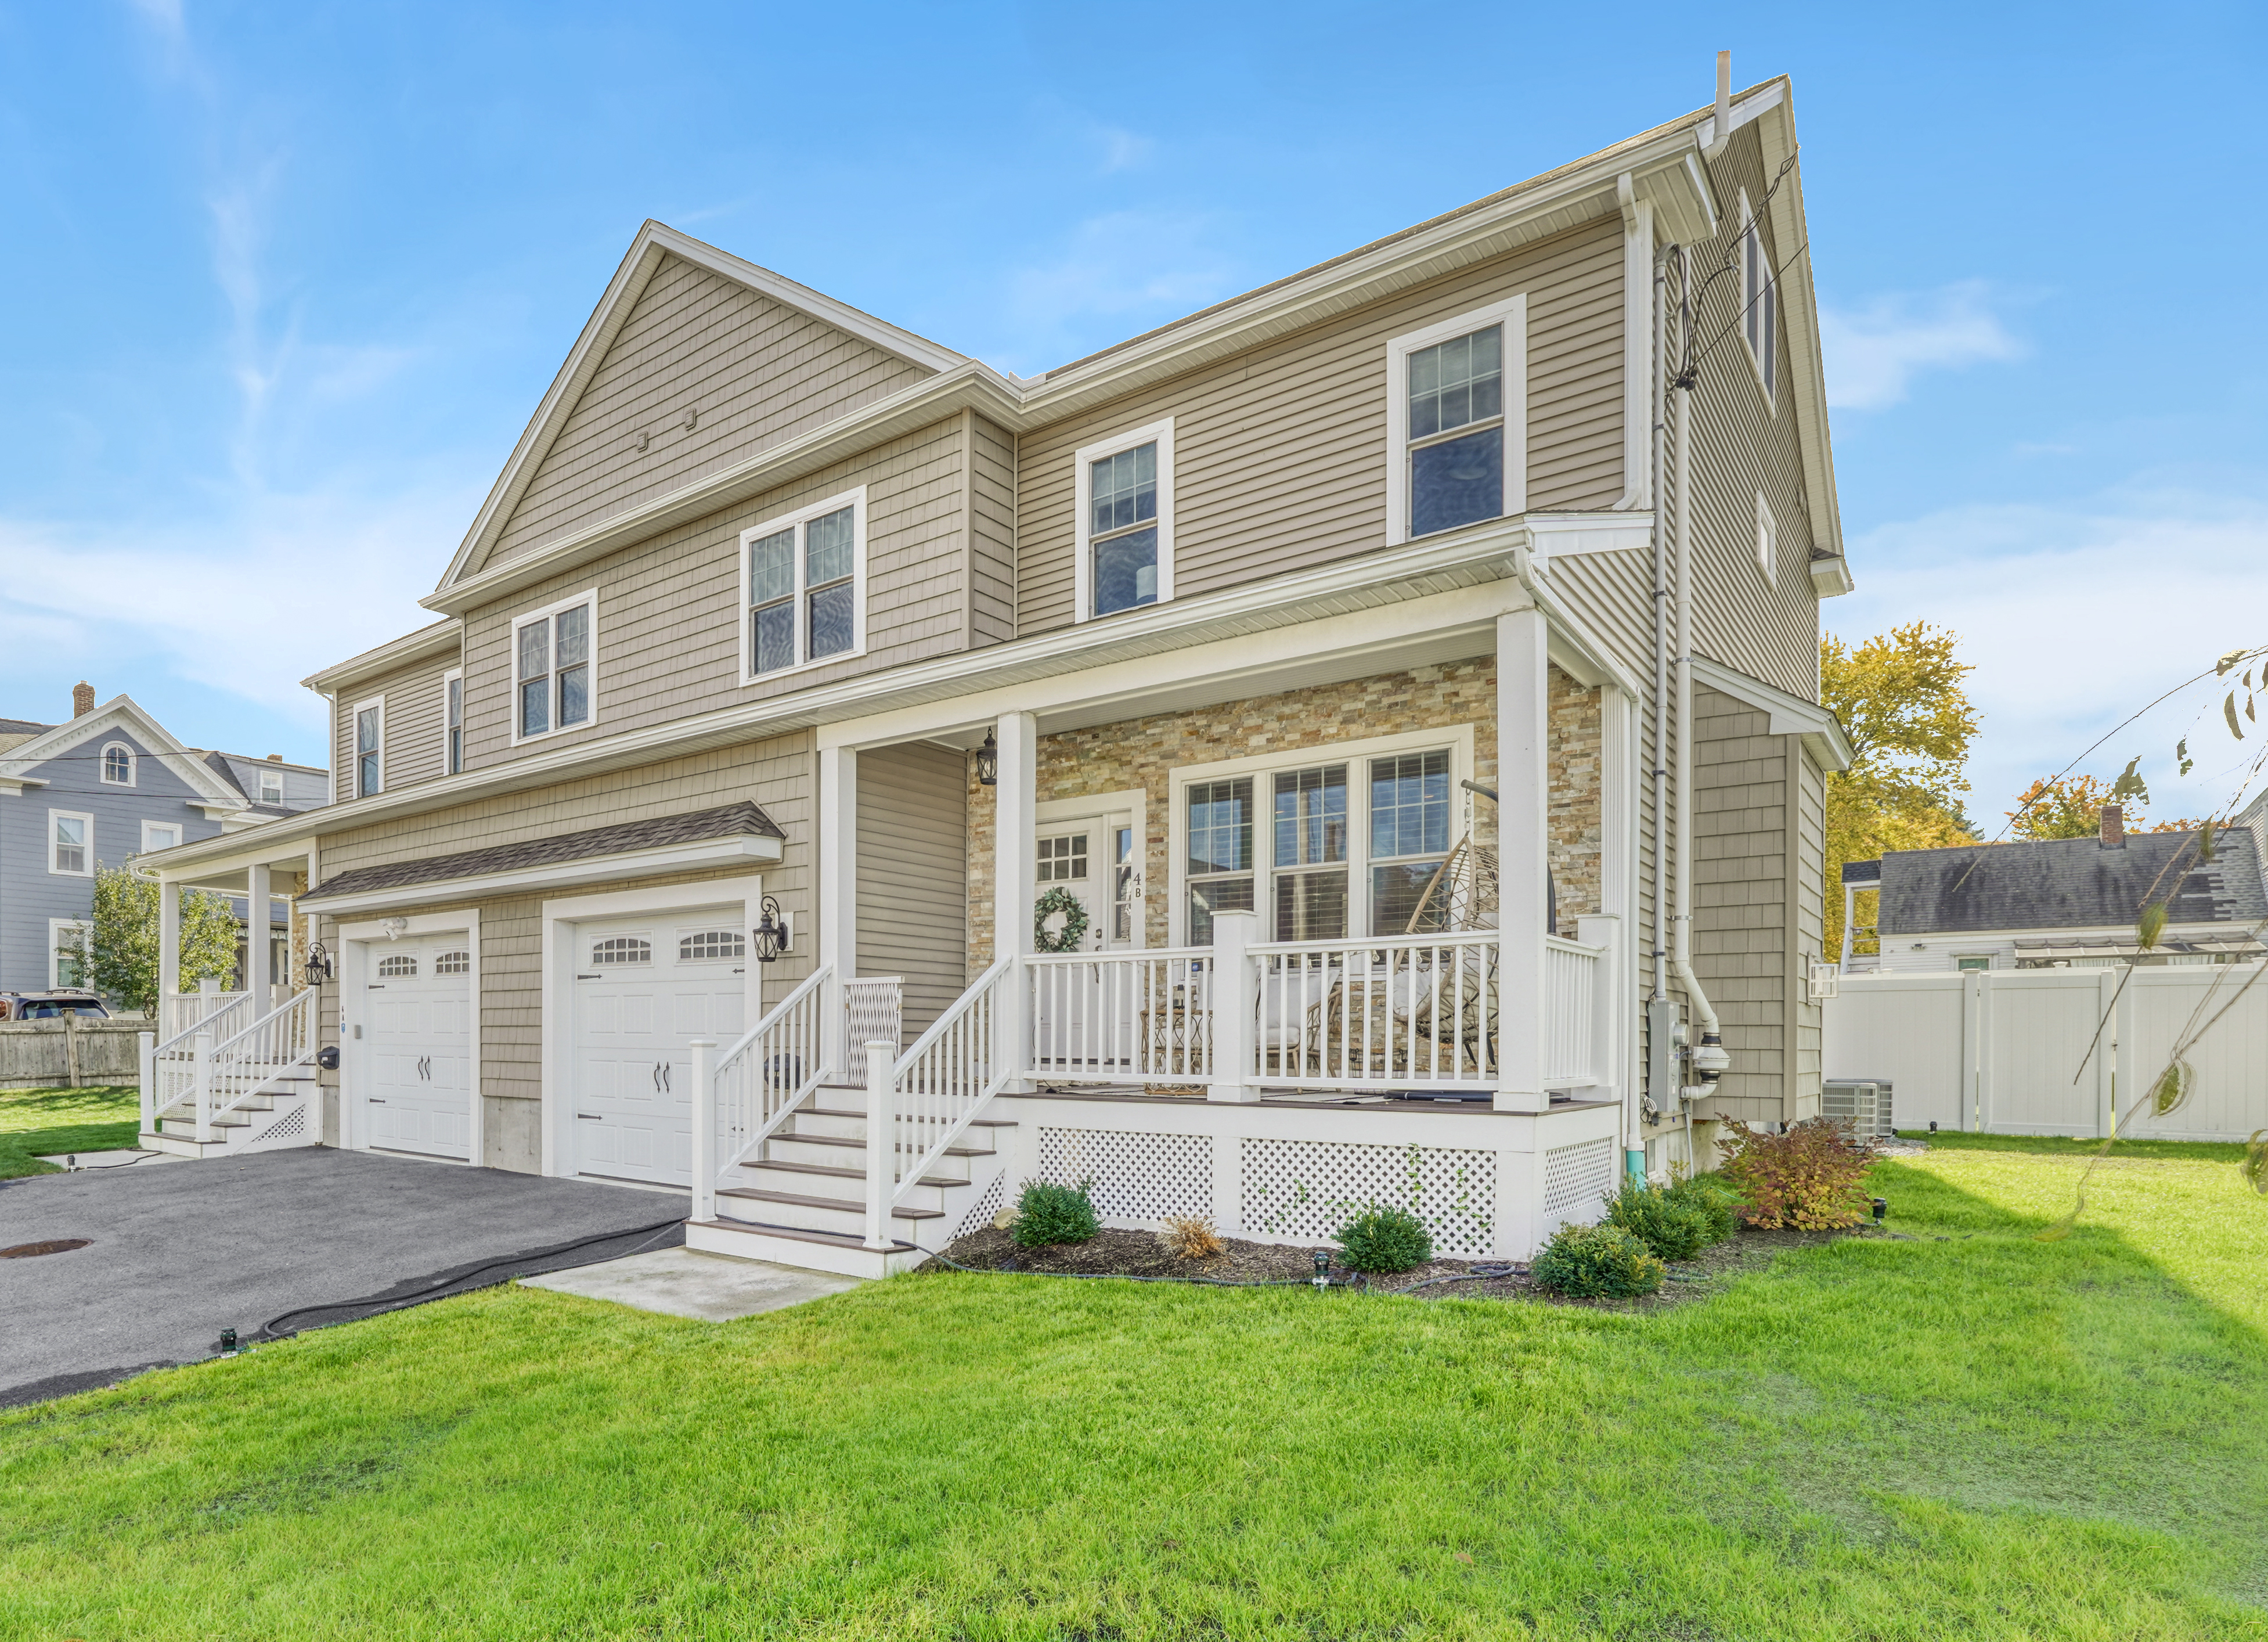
[740, 485, 866, 683]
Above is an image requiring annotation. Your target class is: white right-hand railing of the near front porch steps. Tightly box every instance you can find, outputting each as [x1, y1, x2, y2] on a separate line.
[862, 957, 1025, 1249]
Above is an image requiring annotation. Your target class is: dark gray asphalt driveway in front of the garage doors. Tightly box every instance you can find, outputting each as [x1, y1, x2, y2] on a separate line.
[0, 1146, 685, 1406]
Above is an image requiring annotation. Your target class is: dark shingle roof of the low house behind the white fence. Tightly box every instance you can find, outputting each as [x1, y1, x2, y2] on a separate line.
[1878, 828, 2268, 939]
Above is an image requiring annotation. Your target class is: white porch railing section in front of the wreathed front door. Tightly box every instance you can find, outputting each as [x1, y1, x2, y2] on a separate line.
[1023, 948, 1213, 1082]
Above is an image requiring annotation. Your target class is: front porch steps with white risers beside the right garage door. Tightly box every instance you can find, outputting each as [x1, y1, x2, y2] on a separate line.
[685, 1084, 1016, 1277]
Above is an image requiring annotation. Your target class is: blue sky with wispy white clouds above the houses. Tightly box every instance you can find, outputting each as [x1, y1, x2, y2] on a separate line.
[0, 0, 2268, 821]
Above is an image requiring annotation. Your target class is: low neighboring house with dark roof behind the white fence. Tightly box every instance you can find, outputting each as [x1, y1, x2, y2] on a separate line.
[1841, 801, 2268, 975]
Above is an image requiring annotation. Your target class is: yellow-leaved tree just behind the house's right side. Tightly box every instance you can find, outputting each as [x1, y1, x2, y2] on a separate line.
[1819, 621, 1978, 953]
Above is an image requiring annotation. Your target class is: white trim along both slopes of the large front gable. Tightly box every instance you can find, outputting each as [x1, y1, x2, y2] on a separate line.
[440, 218, 968, 588]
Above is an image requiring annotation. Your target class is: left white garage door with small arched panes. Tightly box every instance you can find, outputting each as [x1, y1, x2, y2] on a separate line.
[363, 934, 472, 1157]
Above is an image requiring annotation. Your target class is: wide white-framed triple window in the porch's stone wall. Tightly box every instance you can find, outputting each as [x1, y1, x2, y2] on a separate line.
[1175, 728, 1472, 946]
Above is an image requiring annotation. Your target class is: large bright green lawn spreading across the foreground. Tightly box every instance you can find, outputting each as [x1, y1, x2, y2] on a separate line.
[0, 1136, 2268, 1642]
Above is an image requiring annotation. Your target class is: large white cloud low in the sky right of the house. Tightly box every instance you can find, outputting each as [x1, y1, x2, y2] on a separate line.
[1823, 488, 2268, 826]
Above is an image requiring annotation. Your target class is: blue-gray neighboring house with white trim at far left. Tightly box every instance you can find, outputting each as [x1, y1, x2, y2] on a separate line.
[0, 683, 331, 991]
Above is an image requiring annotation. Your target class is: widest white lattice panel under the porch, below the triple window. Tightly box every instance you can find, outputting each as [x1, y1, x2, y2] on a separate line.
[1238, 1139, 1497, 1254]
